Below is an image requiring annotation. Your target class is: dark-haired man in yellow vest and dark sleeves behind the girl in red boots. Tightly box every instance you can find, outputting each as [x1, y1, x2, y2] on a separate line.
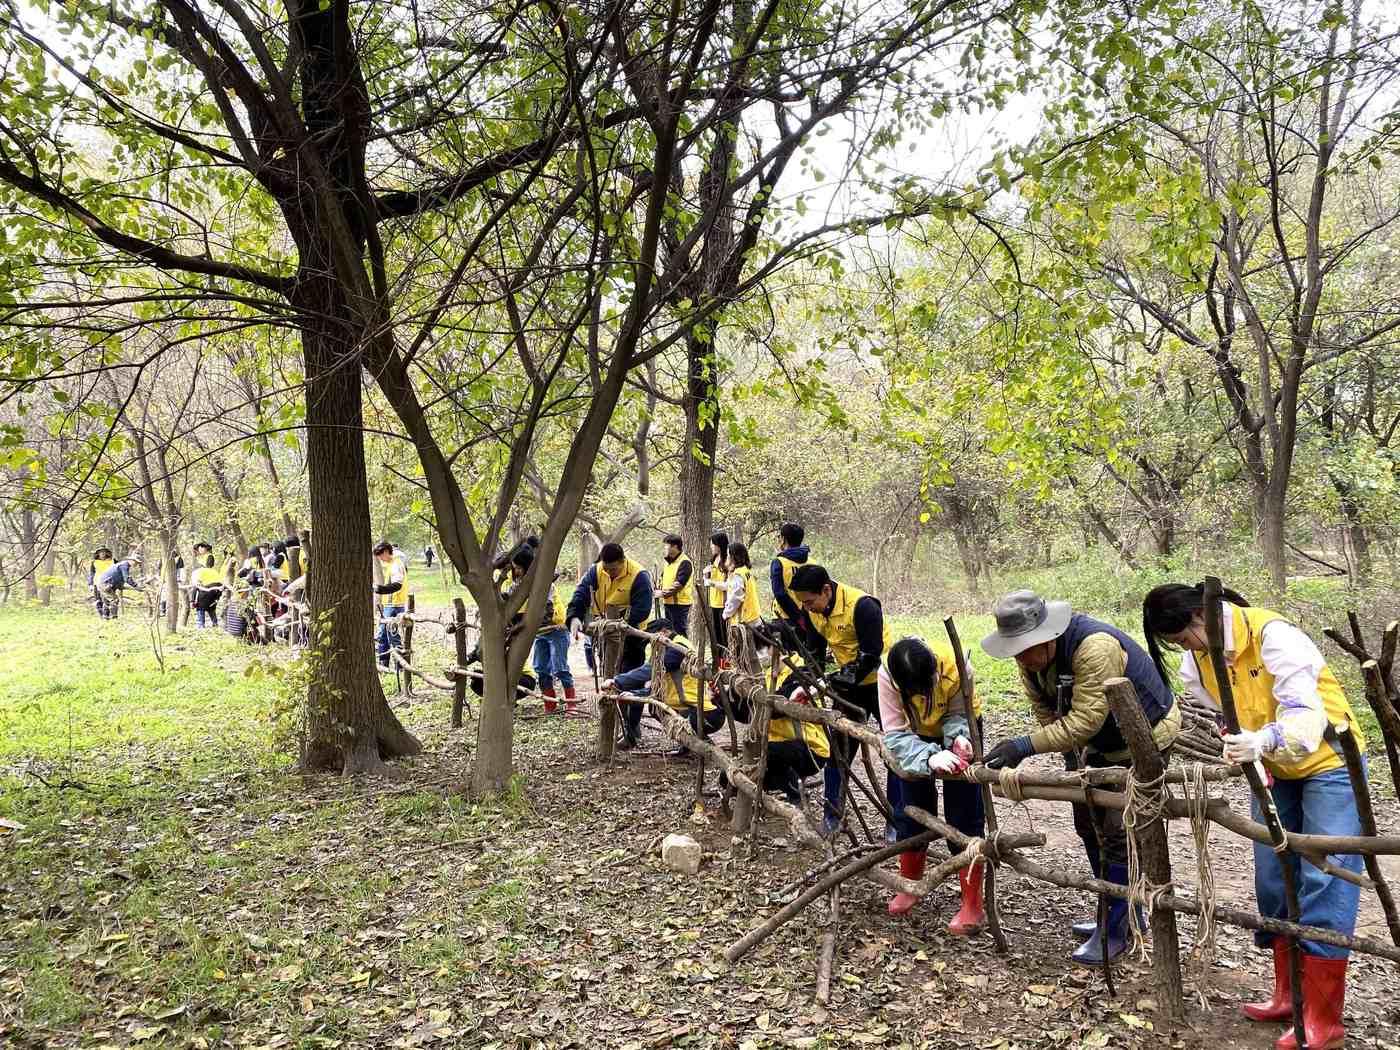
[788, 566, 889, 834]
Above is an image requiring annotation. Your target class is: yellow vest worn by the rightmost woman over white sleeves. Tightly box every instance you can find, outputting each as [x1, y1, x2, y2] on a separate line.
[1190, 605, 1366, 780]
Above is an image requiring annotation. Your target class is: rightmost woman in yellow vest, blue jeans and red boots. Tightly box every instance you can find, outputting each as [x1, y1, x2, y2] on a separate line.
[1142, 584, 1365, 1050]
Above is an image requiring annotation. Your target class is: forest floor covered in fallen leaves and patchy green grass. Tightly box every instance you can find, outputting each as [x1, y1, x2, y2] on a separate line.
[0, 615, 1400, 1050]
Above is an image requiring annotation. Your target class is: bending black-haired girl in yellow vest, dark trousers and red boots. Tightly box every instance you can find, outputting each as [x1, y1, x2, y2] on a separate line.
[878, 638, 987, 937]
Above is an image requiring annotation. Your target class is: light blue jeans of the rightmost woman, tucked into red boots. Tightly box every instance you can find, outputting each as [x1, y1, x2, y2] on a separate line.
[1252, 769, 1362, 959]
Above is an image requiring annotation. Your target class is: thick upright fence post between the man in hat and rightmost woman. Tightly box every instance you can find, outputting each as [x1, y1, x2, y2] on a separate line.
[1103, 678, 1186, 1021]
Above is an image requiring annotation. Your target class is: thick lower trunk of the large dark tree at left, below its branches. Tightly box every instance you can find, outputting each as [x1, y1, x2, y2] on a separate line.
[293, 275, 423, 776]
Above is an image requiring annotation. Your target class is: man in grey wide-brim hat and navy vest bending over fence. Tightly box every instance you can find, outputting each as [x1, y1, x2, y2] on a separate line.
[981, 591, 1182, 966]
